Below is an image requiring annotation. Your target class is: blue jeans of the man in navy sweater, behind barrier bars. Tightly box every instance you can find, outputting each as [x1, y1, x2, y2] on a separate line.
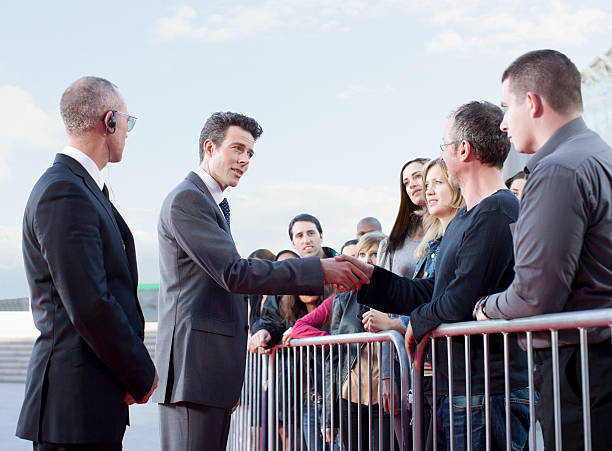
[437, 388, 529, 450]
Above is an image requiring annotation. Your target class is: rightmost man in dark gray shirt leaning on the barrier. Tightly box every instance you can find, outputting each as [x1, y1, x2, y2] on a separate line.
[475, 50, 612, 450]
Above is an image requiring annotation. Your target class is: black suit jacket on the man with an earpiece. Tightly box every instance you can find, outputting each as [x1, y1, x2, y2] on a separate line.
[17, 154, 155, 443]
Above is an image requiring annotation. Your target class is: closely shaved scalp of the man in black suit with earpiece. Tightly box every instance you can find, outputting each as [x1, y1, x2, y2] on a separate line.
[60, 77, 123, 136]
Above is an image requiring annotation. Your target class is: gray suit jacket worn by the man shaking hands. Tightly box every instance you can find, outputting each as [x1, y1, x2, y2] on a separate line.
[153, 172, 323, 408]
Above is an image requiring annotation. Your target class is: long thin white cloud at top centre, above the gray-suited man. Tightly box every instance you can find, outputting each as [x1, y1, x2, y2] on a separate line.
[153, 0, 417, 42]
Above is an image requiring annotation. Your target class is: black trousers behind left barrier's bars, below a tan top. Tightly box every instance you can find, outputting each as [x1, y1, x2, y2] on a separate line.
[341, 399, 391, 451]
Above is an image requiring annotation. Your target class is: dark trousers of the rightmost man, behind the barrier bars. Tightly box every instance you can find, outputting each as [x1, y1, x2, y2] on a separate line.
[534, 340, 612, 451]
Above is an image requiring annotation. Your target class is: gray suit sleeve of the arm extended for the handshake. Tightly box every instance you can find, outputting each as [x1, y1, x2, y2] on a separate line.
[161, 190, 323, 294]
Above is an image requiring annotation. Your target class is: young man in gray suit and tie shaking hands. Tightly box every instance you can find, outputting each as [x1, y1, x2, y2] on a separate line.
[153, 113, 368, 451]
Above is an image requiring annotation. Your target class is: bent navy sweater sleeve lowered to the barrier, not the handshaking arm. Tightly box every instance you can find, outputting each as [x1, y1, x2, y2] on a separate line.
[410, 211, 514, 342]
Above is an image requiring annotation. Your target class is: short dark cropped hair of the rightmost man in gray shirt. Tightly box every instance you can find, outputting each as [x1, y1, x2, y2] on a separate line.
[502, 50, 582, 114]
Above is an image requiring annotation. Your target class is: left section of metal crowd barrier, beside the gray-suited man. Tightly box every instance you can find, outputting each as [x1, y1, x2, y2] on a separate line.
[227, 331, 411, 451]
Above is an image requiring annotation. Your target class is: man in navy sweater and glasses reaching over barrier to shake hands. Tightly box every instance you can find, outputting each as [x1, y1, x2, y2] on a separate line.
[338, 102, 528, 449]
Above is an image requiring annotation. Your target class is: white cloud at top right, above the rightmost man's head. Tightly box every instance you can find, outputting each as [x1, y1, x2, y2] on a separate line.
[426, 0, 612, 54]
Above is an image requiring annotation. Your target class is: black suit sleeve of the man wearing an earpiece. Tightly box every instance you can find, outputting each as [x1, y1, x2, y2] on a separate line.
[32, 182, 155, 400]
